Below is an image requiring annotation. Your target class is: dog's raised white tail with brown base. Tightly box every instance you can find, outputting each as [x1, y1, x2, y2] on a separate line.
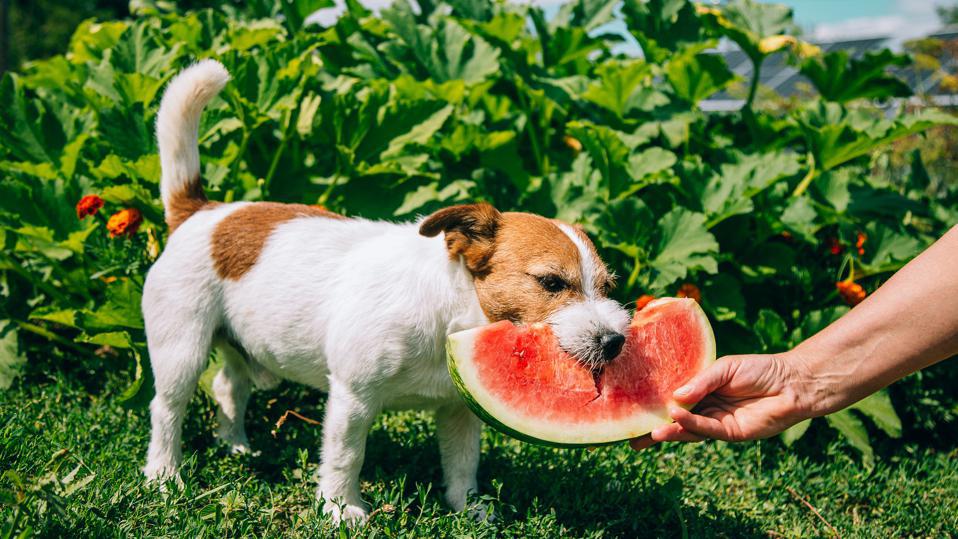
[156, 60, 230, 232]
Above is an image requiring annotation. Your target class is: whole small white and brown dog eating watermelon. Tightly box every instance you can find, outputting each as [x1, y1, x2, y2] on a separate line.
[142, 60, 629, 523]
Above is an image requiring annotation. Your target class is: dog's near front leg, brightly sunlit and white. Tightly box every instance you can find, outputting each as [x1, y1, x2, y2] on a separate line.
[316, 377, 380, 524]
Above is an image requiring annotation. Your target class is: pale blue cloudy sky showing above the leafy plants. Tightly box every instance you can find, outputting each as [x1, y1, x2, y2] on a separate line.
[310, 0, 958, 45]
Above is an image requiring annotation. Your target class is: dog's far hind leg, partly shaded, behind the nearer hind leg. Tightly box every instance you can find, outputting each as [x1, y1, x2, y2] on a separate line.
[213, 339, 250, 453]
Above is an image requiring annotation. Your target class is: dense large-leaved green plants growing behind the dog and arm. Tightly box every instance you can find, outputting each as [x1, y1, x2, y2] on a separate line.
[0, 0, 958, 536]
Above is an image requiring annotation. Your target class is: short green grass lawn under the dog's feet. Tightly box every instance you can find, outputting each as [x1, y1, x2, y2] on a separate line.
[0, 373, 958, 538]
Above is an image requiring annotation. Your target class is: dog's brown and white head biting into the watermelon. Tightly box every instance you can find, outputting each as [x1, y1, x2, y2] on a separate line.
[419, 204, 629, 368]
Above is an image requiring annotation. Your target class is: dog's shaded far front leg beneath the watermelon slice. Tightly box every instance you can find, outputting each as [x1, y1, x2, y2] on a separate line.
[436, 403, 482, 511]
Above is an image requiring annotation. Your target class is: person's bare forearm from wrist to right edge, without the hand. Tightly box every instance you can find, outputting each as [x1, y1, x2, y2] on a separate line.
[784, 227, 958, 416]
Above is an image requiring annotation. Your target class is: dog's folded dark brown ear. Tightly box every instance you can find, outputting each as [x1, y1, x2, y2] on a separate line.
[419, 203, 502, 274]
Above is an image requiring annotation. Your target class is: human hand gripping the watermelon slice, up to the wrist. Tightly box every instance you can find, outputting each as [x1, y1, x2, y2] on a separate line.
[630, 354, 814, 450]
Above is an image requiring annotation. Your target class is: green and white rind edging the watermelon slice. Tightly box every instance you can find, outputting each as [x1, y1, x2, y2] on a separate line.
[446, 298, 716, 448]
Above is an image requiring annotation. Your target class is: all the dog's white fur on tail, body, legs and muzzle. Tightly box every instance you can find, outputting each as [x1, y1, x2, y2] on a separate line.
[143, 60, 628, 521]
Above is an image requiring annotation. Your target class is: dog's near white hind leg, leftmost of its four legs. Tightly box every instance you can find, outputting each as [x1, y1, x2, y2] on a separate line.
[143, 296, 214, 481]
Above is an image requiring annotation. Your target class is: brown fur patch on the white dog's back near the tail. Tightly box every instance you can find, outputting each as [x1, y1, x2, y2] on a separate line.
[212, 202, 345, 281]
